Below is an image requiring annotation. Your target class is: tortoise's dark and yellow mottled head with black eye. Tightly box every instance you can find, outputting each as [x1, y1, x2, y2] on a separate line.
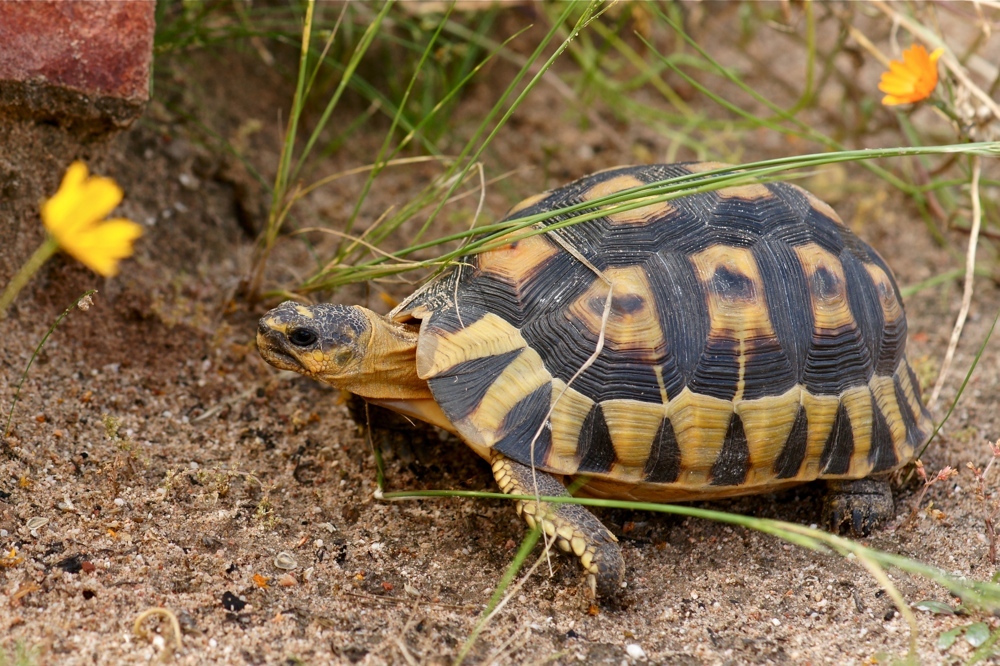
[257, 301, 378, 388]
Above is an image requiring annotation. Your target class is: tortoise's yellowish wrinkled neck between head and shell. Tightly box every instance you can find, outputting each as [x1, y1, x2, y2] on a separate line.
[343, 308, 431, 400]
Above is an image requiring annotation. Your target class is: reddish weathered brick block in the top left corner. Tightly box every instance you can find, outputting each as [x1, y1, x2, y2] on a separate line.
[0, 0, 156, 136]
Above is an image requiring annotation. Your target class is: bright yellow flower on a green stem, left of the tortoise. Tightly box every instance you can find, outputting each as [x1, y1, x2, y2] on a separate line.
[42, 162, 142, 277]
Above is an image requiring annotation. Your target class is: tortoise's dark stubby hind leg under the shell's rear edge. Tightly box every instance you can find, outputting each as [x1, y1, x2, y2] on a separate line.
[823, 477, 895, 536]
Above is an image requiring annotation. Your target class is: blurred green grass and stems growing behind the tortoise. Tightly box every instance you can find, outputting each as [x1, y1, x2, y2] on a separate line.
[157, 2, 1000, 306]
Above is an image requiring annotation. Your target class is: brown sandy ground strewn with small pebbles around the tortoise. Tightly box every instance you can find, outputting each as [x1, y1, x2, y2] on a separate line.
[0, 5, 1000, 664]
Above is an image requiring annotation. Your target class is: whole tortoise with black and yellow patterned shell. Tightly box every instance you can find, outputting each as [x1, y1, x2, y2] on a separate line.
[257, 163, 930, 596]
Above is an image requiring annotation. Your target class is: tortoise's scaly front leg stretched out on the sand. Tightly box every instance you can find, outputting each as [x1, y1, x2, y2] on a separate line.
[490, 451, 625, 598]
